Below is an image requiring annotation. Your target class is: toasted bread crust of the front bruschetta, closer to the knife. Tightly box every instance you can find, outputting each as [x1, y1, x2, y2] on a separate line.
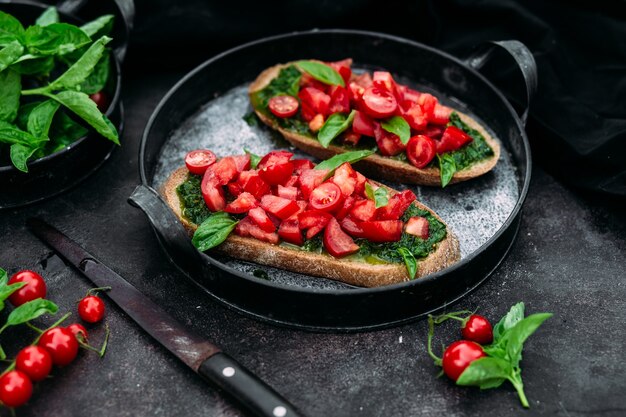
[161, 167, 460, 287]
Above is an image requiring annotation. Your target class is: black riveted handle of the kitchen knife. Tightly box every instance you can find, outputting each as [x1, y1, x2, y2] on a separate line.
[198, 352, 302, 417]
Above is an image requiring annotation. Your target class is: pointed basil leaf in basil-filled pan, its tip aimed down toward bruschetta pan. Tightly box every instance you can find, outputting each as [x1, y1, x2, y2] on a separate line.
[46, 91, 120, 145]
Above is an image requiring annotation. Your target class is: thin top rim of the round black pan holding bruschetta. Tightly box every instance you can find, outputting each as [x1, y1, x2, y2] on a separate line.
[138, 29, 532, 296]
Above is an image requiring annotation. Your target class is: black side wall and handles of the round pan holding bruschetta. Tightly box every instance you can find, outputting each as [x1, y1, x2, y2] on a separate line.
[129, 30, 536, 331]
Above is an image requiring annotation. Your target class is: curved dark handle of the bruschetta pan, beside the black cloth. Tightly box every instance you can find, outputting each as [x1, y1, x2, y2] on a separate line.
[465, 40, 538, 126]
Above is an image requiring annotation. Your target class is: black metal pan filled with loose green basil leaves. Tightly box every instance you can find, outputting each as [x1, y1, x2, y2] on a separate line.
[0, 0, 134, 210]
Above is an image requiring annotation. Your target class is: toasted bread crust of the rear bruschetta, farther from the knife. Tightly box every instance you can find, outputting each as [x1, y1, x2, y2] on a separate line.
[248, 63, 500, 186]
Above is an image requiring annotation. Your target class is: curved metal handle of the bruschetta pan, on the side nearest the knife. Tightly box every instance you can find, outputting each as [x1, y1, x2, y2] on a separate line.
[128, 184, 202, 276]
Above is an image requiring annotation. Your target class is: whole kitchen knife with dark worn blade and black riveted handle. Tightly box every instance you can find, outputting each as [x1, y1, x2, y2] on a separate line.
[27, 219, 302, 417]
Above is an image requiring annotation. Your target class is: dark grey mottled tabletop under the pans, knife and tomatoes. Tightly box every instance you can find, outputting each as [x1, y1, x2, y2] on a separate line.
[0, 70, 626, 416]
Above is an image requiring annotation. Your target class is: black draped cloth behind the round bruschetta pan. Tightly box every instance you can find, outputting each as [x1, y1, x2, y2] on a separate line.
[126, 0, 626, 197]
